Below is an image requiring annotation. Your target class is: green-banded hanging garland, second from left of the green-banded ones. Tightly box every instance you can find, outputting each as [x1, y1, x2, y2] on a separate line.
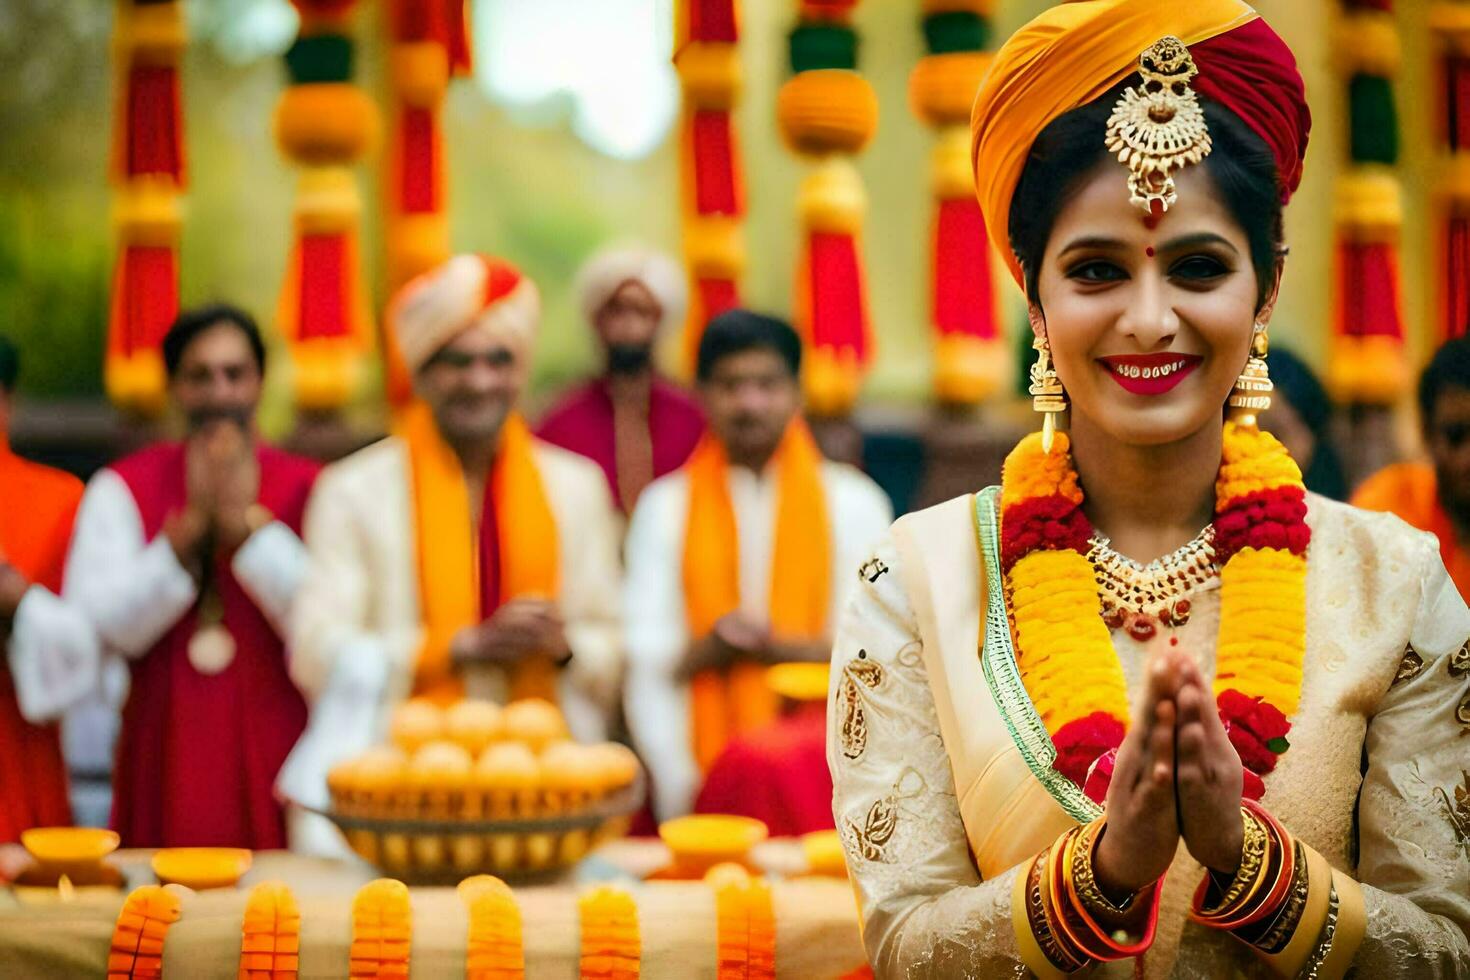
[776, 0, 878, 416]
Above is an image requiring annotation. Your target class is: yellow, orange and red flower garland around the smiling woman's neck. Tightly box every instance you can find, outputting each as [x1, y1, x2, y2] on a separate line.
[1001, 422, 1311, 802]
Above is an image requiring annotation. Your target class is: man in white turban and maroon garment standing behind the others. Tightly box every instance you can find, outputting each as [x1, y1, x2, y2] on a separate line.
[537, 247, 704, 513]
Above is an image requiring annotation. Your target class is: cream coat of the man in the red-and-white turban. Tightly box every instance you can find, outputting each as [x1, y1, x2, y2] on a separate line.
[281, 436, 622, 822]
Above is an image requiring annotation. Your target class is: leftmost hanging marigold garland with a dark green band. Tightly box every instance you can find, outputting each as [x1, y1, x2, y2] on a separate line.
[275, 0, 378, 411]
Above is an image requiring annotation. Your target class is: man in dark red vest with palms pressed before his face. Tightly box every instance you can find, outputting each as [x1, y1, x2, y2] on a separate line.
[65, 306, 316, 849]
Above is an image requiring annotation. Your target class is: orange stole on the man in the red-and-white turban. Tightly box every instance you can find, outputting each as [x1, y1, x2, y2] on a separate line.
[397, 401, 560, 704]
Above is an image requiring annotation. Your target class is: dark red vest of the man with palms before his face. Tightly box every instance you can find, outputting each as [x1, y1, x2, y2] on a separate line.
[112, 442, 318, 849]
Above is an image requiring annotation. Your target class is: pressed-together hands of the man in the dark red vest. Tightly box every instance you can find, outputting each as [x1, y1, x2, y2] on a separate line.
[163, 417, 260, 574]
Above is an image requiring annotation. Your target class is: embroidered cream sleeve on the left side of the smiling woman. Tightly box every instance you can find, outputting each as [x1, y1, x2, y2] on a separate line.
[828, 538, 1026, 977]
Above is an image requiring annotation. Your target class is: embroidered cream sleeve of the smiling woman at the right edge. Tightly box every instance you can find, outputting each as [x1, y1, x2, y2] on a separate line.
[1354, 547, 1470, 980]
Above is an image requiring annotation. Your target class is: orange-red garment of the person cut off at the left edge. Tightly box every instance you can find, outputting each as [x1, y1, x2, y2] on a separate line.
[0, 436, 82, 843]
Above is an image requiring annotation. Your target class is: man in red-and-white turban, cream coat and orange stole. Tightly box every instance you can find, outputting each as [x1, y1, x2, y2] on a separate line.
[281, 254, 622, 849]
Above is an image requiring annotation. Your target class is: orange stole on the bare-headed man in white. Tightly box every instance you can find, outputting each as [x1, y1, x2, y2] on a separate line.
[684, 419, 832, 770]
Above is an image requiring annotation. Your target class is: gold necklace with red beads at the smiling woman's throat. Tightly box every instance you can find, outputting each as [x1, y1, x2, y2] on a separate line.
[1088, 525, 1220, 639]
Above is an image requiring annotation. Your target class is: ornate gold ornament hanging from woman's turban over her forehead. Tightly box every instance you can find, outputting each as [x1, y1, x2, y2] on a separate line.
[1107, 35, 1211, 215]
